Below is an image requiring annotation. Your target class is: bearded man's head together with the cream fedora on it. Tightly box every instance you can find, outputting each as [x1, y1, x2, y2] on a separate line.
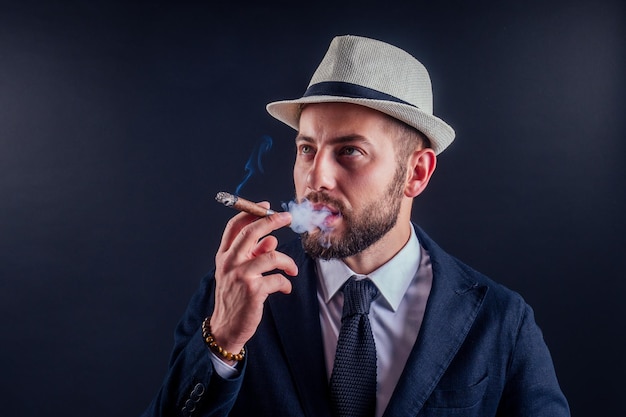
[267, 36, 454, 259]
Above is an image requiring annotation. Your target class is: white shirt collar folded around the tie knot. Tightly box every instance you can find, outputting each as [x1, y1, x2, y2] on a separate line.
[316, 224, 421, 311]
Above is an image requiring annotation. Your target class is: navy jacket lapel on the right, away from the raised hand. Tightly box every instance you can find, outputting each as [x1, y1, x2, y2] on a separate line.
[384, 227, 487, 416]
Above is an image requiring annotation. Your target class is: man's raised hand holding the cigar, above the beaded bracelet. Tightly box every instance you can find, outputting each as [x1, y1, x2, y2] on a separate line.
[210, 203, 298, 362]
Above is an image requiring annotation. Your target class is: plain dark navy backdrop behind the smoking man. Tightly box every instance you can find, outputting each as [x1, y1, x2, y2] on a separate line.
[0, 0, 626, 417]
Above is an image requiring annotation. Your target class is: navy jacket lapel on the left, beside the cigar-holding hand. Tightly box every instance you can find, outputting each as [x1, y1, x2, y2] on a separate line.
[268, 240, 330, 417]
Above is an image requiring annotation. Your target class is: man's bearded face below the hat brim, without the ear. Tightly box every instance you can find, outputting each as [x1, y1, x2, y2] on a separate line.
[294, 103, 406, 259]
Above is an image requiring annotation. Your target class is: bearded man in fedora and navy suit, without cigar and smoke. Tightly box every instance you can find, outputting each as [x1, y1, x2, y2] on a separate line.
[140, 36, 569, 417]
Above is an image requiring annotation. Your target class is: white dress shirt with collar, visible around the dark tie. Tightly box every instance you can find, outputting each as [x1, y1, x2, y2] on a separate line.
[317, 227, 432, 417]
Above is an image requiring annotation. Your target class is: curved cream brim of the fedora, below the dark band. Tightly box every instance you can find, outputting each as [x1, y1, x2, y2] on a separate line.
[266, 96, 455, 154]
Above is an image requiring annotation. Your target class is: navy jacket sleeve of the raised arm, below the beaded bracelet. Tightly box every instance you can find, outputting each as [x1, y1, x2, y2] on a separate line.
[141, 274, 247, 417]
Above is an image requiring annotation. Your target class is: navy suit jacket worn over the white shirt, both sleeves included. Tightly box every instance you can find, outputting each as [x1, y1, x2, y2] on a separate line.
[143, 227, 570, 417]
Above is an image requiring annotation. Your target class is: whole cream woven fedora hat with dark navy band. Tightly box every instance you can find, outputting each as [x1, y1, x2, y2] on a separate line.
[267, 35, 454, 154]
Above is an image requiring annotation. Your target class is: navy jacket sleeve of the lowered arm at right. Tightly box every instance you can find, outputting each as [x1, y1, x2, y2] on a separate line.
[498, 304, 570, 417]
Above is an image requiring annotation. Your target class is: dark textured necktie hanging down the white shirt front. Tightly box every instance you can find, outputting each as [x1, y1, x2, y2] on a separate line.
[330, 277, 378, 417]
